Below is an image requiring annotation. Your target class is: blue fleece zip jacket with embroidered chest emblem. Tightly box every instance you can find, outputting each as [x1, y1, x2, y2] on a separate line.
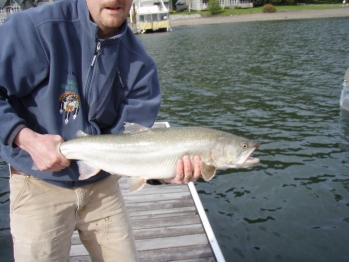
[0, 0, 161, 187]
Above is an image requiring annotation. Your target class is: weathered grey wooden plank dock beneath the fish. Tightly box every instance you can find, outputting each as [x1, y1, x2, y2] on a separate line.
[70, 178, 224, 262]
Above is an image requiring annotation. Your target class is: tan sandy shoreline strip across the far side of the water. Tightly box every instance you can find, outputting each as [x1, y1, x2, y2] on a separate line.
[171, 7, 349, 27]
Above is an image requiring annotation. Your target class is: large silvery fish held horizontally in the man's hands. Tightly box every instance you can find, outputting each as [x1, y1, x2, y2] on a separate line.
[60, 123, 260, 192]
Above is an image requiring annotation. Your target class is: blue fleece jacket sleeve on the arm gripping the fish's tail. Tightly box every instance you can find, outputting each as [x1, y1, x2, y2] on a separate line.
[0, 12, 48, 145]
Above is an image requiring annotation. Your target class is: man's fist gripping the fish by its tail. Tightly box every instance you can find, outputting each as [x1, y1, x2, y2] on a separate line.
[14, 128, 70, 172]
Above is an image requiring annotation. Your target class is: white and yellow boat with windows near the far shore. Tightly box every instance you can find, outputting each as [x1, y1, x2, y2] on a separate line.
[131, 0, 171, 34]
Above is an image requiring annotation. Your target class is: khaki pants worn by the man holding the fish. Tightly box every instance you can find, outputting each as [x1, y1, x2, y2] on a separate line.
[10, 170, 138, 262]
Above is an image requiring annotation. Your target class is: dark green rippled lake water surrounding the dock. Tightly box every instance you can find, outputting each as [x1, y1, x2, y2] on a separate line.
[0, 15, 349, 261]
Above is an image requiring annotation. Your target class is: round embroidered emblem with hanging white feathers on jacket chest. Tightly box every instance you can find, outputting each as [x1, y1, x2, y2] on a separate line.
[59, 91, 80, 124]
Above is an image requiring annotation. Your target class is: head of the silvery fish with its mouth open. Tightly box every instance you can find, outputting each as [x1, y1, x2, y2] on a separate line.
[211, 135, 259, 170]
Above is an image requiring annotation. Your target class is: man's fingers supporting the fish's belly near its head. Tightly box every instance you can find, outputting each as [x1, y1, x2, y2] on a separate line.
[164, 156, 201, 184]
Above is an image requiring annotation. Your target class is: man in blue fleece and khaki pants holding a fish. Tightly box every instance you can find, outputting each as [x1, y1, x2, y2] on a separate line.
[0, 0, 201, 262]
